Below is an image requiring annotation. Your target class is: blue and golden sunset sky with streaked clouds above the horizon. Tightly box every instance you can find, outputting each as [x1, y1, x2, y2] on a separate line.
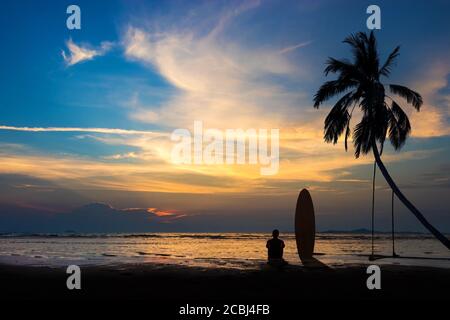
[0, 0, 450, 232]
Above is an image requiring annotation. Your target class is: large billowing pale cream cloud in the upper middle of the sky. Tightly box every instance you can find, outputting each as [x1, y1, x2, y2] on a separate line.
[122, 1, 310, 128]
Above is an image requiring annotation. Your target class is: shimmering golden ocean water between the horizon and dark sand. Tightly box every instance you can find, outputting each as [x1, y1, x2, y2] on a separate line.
[0, 233, 450, 270]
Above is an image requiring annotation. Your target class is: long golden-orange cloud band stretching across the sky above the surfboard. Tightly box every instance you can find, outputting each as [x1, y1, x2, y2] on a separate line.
[0, 138, 433, 194]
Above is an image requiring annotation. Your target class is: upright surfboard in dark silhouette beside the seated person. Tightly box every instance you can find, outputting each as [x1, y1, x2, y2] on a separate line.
[295, 189, 316, 261]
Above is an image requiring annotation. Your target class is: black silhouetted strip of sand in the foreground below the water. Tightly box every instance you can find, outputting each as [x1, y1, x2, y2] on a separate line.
[0, 264, 450, 305]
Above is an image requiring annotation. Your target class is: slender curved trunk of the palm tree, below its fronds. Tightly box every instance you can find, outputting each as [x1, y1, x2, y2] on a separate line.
[372, 143, 450, 250]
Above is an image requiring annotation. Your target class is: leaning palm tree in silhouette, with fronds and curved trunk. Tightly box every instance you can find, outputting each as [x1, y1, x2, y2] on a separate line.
[314, 32, 450, 249]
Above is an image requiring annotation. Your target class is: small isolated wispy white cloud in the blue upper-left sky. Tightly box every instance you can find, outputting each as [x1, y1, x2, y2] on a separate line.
[61, 39, 113, 66]
